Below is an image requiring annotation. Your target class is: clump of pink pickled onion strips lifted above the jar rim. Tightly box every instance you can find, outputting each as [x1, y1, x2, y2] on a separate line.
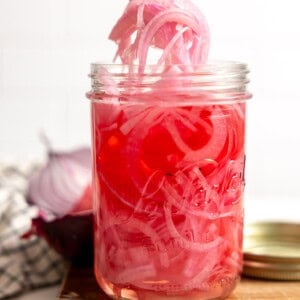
[109, 0, 209, 66]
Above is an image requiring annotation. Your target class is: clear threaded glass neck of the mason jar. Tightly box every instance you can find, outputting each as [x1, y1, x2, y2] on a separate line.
[90, 61, 251, 102]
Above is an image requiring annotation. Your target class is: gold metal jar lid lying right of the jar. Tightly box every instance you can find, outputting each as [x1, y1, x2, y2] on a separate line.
[243, 222, 300, 280]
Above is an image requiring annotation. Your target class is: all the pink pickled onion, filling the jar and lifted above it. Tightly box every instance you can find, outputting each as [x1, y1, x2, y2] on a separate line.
[94, 0, 244, 299]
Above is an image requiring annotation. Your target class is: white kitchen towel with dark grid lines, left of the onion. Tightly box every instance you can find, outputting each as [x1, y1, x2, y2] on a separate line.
[0, 163, 65, 299]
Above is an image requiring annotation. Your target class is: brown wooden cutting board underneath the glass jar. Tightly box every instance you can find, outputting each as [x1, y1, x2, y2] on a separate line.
[58, 266, 300, 300]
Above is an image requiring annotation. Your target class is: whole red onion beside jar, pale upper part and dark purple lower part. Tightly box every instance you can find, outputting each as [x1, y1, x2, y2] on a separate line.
[27, 147, 93, 263]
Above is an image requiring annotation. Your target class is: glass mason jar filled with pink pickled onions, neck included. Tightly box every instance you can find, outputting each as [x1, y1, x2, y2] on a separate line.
[87, 62, 251, 300]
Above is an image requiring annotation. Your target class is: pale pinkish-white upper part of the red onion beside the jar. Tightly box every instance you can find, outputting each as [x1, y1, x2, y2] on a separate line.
[28, 148, 92, 221]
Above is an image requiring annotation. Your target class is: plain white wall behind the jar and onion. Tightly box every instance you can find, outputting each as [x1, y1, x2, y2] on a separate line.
[0, 0, 300, 220]
